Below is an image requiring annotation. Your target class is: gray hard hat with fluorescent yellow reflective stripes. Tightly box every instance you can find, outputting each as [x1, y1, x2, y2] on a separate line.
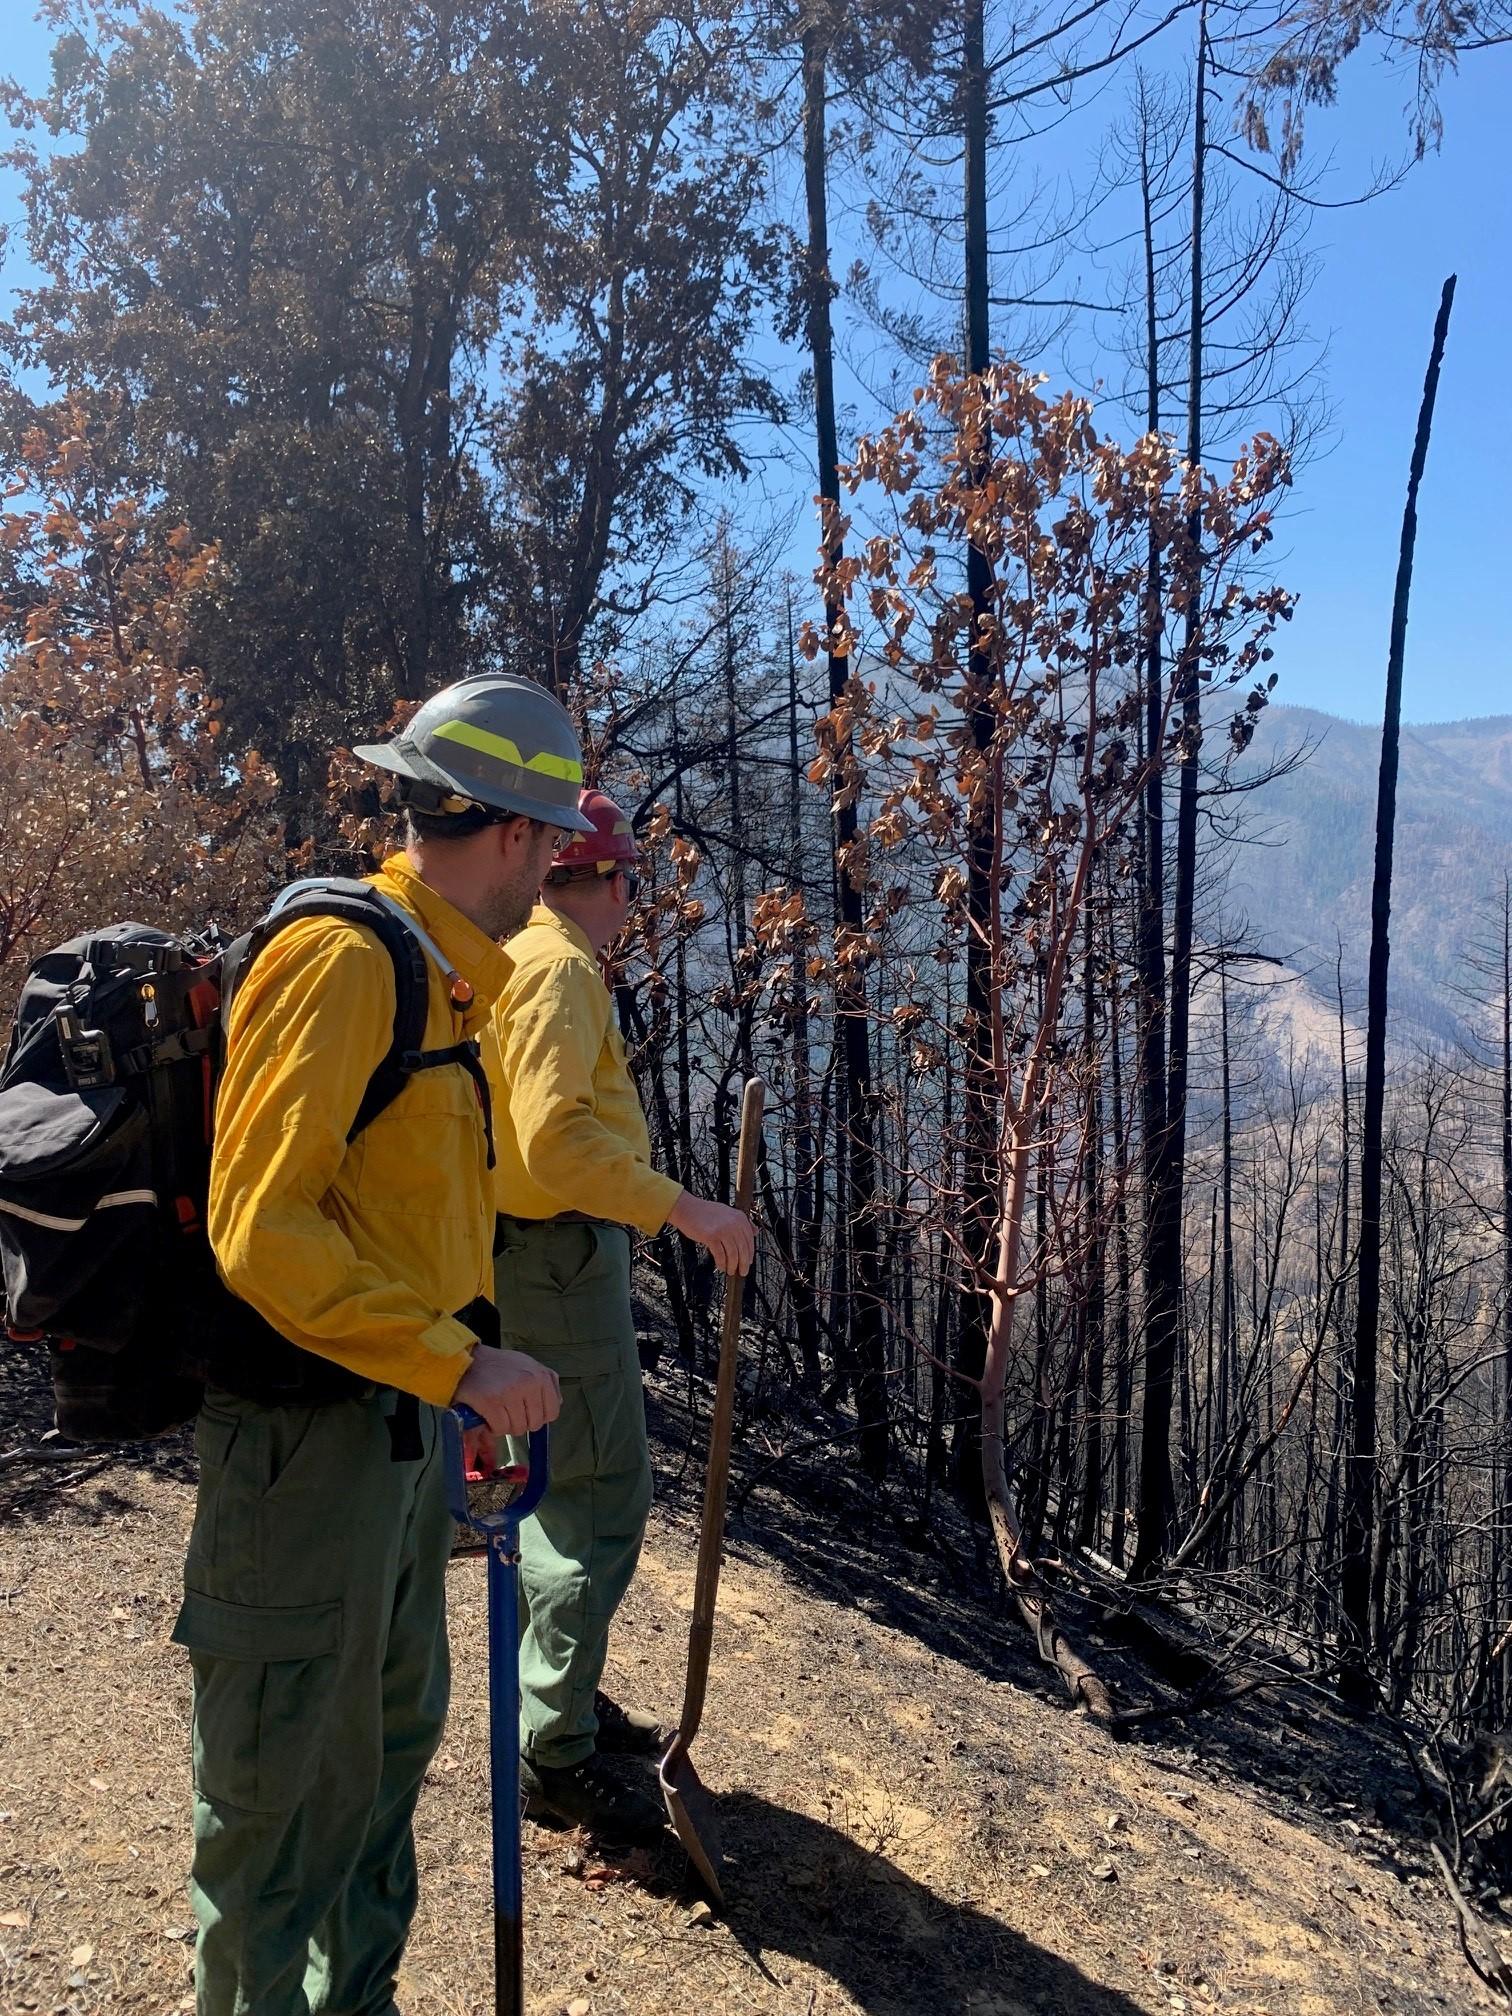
[353, 671, 593, 833]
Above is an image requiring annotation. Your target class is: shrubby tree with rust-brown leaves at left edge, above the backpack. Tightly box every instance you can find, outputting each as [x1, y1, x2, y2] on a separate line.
[0, 401, 282, 1000]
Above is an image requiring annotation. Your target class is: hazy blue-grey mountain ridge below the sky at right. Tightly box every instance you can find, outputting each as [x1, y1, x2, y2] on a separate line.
[1226, 708, 1512, 1042]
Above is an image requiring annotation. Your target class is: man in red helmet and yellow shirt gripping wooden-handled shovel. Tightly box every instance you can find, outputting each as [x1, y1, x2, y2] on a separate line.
[484, 790, 756, 1841]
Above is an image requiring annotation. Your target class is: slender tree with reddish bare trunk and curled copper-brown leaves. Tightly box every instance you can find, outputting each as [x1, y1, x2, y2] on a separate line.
[762, 361, 1290, 1714]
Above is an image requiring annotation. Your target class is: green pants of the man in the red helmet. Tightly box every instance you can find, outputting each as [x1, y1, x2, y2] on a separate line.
[494, 1218, 651, 1768]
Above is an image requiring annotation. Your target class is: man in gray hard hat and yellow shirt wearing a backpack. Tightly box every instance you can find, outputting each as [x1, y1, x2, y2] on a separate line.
[173, 675, 583, 2016]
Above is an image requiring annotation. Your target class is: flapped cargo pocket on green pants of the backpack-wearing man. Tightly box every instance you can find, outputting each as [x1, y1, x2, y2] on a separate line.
[173, 1589, 341, 1812]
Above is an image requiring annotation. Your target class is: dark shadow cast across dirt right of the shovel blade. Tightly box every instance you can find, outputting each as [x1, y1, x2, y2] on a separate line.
[720, 1792, 1139, 2016]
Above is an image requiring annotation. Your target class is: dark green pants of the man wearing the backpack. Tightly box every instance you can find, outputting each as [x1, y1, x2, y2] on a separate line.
[173, 1391, 452, 2016]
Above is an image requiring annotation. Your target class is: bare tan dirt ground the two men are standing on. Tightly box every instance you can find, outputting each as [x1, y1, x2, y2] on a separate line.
[0, 1354, 1500, 2016]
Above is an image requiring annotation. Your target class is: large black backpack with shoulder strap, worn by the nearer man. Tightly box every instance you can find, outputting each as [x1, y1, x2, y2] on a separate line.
[0, 879, 482, 1441]
